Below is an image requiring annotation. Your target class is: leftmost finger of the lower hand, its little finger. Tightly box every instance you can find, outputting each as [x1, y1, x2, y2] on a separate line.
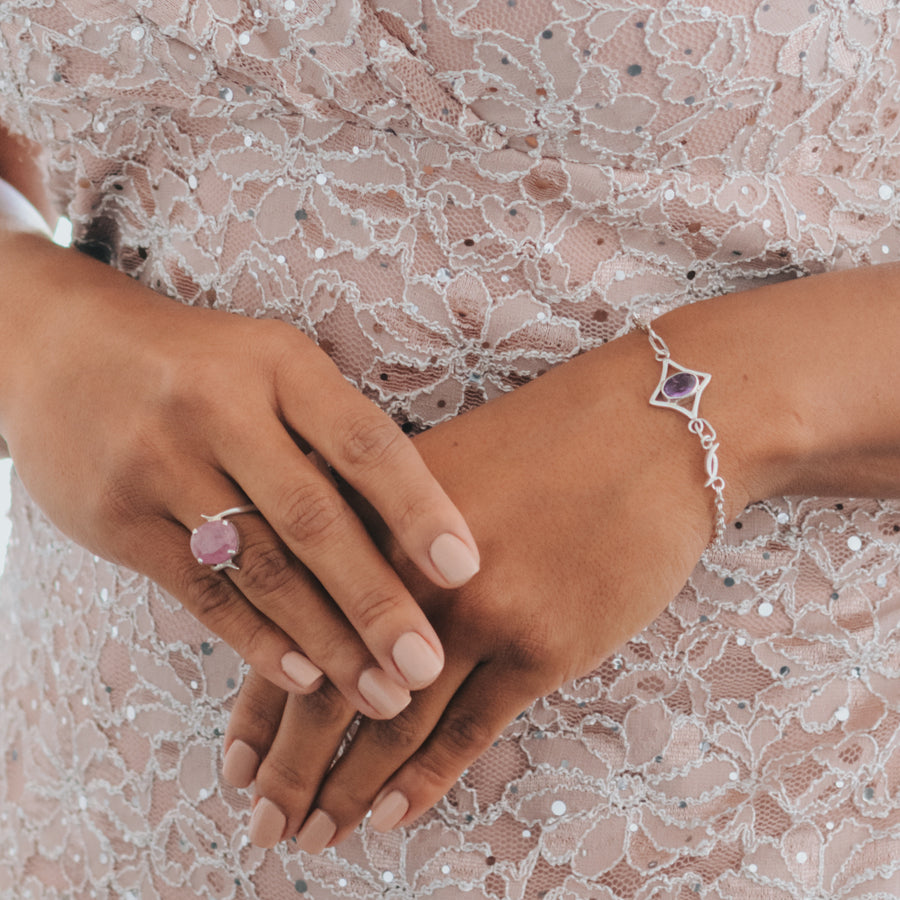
[222, 669, 288, 788]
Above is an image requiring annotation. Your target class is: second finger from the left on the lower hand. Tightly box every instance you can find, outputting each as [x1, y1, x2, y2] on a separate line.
[250, 682, 355, 847]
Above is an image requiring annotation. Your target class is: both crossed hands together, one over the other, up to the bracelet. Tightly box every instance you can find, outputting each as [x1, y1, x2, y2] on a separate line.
[0, 233, 711, 850]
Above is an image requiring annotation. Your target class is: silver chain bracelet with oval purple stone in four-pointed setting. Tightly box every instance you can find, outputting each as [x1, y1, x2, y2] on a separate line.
[634, 316, 725, 542]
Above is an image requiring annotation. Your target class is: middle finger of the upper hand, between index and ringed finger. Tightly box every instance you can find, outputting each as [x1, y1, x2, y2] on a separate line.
[222, 420, 443, 692]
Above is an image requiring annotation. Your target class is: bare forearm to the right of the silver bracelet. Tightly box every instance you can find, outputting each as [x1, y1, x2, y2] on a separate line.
[647, 265, 900, 516]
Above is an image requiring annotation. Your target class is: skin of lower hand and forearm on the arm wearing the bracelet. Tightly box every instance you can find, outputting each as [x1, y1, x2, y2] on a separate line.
[227, 266, 900, 851]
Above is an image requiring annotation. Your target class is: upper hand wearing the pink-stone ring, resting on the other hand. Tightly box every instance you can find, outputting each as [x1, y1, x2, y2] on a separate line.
[0, 232, 478, 718]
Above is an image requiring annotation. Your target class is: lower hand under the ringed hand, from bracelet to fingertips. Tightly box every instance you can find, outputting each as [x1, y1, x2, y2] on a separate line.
[224, 326, 742, 852]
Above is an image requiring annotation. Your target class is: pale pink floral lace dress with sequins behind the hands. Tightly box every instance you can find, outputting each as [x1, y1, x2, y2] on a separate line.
[0, 0, 900, 900]
